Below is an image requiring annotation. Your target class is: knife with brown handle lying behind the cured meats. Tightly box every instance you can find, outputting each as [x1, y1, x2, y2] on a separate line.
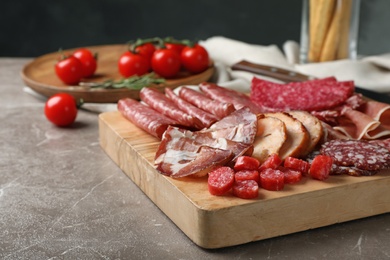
[231, 60, 390, 104]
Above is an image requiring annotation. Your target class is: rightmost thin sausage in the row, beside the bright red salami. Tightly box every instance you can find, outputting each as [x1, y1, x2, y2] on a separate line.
[199, 82, 263, 114]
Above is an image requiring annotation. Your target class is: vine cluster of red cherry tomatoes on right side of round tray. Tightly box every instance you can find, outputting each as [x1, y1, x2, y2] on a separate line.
[118, 37, 210, 78]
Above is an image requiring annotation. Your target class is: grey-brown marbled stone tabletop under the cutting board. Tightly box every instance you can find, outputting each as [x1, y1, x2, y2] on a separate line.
[0, 58, 390, 259]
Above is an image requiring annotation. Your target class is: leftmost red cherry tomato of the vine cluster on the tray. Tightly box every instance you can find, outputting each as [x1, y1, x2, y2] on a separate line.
[118, 51, 150, 78]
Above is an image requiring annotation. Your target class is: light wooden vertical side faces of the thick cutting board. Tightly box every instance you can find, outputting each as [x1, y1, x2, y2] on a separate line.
[99, 112, 390, 249]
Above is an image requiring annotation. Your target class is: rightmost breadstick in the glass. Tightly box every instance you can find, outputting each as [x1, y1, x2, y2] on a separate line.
[336, 0, 353, 59]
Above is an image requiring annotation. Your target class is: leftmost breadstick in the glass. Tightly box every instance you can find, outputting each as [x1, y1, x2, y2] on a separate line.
[308, 0, 336, 62]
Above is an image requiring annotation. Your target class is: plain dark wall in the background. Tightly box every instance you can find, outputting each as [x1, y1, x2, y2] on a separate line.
[0, 0, 390, 57]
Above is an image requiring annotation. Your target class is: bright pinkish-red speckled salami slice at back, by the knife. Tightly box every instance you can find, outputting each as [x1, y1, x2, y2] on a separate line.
[250, 77, 354, 111]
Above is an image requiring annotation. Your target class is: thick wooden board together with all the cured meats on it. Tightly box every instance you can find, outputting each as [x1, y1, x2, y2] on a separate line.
[99, 74, 390, 248]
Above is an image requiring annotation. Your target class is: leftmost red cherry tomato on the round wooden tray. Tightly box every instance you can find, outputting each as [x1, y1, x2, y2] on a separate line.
[55, 56, 83, 85]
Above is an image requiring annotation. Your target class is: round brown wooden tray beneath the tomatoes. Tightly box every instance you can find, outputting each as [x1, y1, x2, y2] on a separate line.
[21, 44, 214, 103]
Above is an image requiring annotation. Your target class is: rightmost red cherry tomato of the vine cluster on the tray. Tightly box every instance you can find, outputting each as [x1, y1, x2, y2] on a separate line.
[181, 44, 209, 73]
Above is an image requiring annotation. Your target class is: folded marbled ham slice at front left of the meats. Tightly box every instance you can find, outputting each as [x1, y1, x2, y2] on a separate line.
[155, 127, 253, 178]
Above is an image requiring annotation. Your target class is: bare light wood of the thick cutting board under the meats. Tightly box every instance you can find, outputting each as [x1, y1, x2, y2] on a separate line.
[99, 112, 390, 248]
